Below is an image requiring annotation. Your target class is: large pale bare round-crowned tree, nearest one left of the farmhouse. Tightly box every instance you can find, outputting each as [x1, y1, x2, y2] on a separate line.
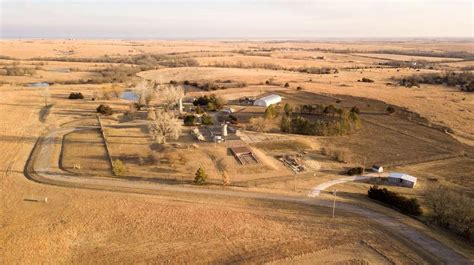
[148, 109, 182, 144]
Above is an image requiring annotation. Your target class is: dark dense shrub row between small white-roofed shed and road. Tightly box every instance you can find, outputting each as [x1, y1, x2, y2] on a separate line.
[367, 186, 423, 216]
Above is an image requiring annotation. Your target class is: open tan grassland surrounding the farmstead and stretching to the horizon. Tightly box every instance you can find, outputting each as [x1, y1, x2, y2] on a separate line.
[0, 40, 474, 264]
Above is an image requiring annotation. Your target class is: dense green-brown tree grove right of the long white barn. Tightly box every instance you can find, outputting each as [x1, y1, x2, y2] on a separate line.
[280, 105, 362, 136]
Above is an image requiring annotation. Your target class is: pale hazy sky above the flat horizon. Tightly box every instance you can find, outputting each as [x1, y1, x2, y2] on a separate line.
[0, 0, 474, 39]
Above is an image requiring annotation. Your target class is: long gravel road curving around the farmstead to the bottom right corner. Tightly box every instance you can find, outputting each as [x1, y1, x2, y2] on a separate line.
[25, 127, 472, 264]
